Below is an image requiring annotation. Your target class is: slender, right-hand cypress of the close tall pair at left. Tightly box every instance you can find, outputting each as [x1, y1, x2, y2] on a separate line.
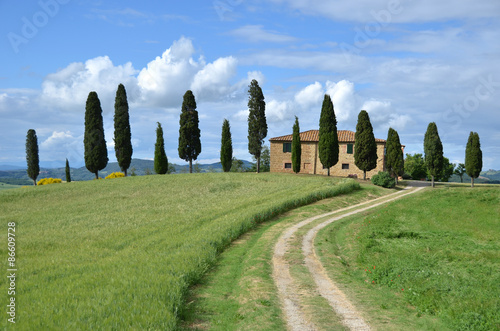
[114, 84, 132, 176]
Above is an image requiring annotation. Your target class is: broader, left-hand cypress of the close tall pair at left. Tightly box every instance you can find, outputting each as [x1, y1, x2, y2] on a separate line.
[83, 92, 108, 179]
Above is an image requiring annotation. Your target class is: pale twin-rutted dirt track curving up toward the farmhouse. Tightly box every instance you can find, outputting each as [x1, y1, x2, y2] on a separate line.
[272, 188, 422, 331]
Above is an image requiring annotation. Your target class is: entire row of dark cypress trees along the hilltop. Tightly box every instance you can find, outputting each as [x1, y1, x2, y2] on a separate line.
[26, 79, 482, 187]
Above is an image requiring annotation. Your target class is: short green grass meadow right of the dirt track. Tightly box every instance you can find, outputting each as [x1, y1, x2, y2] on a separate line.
[316, 187, 500, 330]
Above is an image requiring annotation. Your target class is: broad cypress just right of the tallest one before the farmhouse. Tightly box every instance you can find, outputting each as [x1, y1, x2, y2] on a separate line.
[354, 110, 378, 180]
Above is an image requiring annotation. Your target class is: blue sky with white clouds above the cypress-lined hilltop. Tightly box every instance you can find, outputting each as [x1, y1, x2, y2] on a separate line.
[0, 0, 500, 170]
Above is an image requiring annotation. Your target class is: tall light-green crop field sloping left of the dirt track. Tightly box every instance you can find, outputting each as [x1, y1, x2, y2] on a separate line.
[0, 173, 359, 330]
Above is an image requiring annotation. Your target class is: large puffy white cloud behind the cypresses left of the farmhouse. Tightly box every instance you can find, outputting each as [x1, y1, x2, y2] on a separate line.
[35, 37, 250, 112]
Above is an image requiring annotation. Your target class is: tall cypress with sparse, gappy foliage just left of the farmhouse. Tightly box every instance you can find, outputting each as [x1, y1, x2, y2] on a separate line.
[248, 79, 267, 173]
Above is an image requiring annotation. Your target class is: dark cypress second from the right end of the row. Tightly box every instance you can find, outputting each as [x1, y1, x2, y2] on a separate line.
[424, 122, 443, 187]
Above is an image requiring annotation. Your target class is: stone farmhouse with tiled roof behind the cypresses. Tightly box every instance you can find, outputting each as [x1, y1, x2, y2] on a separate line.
[269, 130, 386, 178]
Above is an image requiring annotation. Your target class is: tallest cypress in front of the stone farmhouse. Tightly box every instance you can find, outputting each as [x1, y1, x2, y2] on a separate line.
[318, 94, 339, 176]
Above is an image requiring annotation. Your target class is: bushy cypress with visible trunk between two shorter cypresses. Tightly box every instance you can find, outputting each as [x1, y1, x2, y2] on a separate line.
[178, 90, 201, 173]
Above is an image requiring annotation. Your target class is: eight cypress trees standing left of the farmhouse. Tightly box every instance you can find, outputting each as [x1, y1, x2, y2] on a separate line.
[26, 79, 267, 185]
